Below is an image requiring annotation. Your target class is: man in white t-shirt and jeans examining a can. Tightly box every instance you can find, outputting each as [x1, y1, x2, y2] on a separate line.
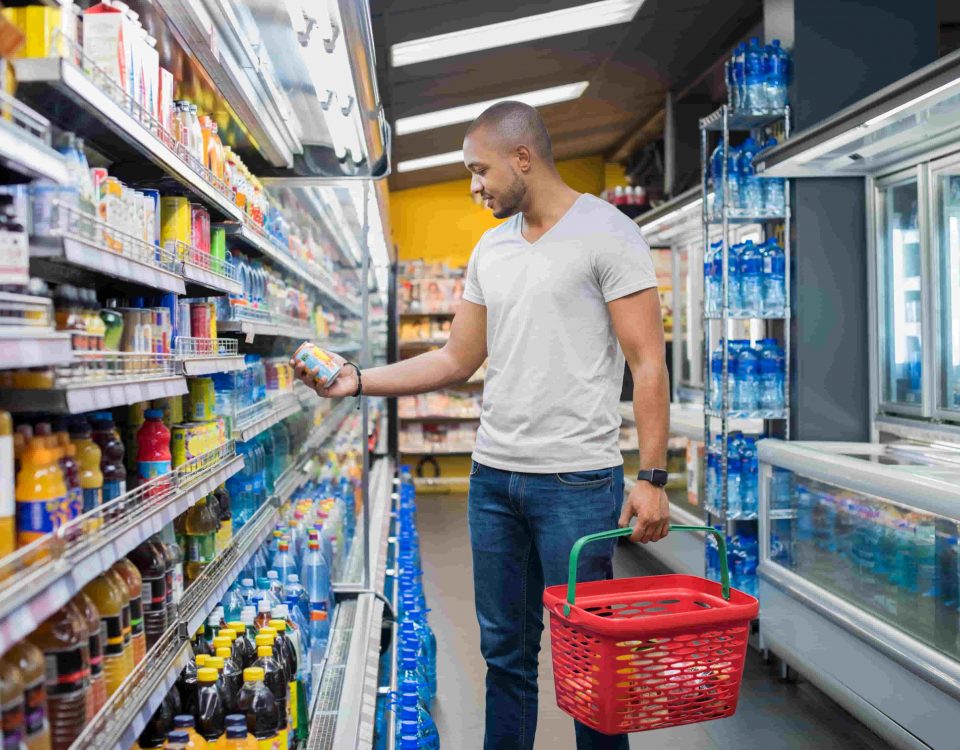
[297, 102, 669, 750]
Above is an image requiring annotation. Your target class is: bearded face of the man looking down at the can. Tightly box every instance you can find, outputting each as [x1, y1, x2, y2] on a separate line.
[463, 128, 527, 219]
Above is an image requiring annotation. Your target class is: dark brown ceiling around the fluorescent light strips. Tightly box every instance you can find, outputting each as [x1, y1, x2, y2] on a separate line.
[371, 0, 762, 189]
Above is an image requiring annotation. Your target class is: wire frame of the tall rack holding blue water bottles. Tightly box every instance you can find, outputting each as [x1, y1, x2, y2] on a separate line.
[700, 104, 791, 533]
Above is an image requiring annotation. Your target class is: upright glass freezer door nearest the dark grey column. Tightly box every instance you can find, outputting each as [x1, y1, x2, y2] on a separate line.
[877, 176, 923, 413]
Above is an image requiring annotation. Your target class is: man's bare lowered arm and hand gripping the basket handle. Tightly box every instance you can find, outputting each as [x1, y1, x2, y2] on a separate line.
[607, 288, 670, 542]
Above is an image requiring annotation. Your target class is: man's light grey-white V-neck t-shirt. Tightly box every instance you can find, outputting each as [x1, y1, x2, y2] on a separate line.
[463, 194, 657, 473]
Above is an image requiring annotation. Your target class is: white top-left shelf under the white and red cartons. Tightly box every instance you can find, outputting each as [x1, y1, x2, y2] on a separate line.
[13, 57, 242, 222]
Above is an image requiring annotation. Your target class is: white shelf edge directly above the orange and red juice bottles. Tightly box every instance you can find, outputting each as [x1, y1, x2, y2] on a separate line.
[0, 376, 187, 414]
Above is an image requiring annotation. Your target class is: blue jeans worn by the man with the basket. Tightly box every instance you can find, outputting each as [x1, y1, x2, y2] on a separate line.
[468, 462, 628, 750]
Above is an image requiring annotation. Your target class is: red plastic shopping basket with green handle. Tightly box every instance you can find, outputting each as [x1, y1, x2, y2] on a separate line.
[543, 526, 759, 734]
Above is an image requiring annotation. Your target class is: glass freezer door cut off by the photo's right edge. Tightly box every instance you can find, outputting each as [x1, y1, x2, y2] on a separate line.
[932, 160, 960, 419]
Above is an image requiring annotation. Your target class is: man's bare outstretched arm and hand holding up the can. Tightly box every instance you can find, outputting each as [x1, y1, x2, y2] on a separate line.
[294, 300, 487, 398]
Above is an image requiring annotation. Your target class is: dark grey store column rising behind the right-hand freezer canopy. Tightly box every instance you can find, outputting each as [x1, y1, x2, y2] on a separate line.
[764, 0, 937, 441]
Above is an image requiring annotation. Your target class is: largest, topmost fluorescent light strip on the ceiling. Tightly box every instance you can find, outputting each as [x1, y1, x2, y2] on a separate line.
[390, 0, 644, 68]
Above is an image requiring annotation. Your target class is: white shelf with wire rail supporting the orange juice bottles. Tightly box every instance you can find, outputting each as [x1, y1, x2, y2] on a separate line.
[0, 443, 243, 654]
